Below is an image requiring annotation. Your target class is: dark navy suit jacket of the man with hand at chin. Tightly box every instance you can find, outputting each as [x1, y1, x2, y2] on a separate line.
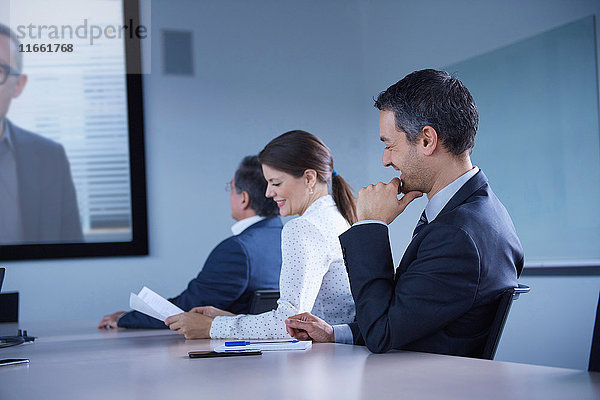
[340, 171, 523, 357]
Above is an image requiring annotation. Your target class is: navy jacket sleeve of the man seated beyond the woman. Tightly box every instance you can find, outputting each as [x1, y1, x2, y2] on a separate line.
[118, 237, 250, 328]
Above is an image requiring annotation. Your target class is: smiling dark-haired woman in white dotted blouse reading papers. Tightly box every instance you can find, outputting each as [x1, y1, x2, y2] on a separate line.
[166, 130, 356, 339]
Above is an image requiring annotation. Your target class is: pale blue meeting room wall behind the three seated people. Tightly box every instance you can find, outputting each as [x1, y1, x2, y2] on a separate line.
[3, 0, 600, 369]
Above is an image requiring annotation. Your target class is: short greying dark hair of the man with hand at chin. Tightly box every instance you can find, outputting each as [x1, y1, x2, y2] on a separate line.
[375, 69, 479, 155]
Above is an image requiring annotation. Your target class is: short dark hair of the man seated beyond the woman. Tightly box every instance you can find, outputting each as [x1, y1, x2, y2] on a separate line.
[234, 156, 279, 217]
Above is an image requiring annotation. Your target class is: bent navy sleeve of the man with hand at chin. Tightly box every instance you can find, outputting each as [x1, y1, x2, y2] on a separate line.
[340, 224, 479, 353]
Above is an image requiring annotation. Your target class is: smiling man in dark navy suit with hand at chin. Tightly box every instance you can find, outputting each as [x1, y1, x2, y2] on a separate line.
[286, 70, 523, 357]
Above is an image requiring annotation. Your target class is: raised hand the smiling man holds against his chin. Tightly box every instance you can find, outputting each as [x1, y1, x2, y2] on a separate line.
[356, 178, 423, 224]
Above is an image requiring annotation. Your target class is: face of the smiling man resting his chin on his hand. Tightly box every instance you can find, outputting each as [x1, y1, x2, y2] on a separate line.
[379, 111, 429, 193]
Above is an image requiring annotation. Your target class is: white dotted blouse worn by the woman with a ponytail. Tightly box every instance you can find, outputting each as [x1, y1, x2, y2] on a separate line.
[210, 195, 355, 339]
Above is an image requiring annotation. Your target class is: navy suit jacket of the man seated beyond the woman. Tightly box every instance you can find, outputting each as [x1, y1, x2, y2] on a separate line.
[118, 217, 283, 328]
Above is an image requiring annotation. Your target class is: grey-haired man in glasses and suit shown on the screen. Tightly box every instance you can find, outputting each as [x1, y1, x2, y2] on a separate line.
[0, 24, 83, 244]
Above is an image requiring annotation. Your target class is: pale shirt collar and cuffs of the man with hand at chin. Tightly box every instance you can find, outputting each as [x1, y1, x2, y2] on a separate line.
[333, 167, 479, 344]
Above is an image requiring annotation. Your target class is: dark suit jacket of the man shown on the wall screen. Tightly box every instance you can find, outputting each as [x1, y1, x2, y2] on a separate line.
[6, 120, 83, 243]
